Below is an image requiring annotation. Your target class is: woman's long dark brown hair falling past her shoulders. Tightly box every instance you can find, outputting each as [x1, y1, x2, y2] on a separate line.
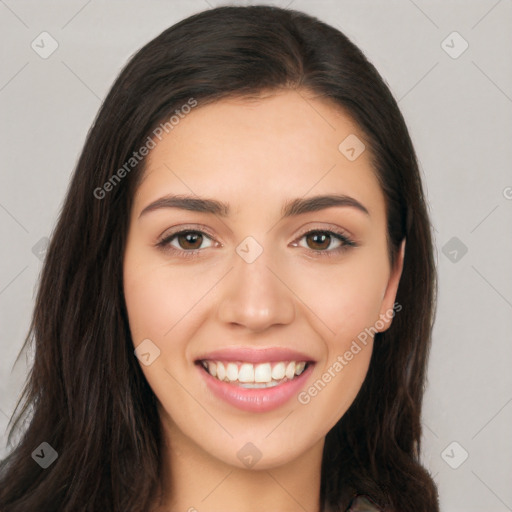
[0, 6, 438, 512]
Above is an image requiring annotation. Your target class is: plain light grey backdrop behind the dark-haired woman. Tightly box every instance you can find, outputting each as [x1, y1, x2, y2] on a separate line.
[0, 0, 512, 512]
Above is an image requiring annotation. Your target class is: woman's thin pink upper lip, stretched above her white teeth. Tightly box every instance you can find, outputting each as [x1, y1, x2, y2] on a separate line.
[195, 347, 315, 363]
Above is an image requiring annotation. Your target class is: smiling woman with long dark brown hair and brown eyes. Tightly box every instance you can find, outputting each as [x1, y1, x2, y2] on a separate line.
[0, 6, 438, 512]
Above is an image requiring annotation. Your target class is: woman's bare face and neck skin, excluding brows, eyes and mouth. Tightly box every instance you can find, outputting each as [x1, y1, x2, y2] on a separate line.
[123, 91, 404, 512]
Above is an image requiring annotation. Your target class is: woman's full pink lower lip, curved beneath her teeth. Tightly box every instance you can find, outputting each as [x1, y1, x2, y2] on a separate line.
[198, 364, 314, 412]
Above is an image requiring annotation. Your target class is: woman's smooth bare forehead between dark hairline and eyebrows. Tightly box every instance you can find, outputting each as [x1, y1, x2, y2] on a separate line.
[136, 91, 384, 220]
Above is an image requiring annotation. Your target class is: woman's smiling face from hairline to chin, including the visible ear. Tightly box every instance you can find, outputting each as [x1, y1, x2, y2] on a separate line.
[124, 91, 403, 469]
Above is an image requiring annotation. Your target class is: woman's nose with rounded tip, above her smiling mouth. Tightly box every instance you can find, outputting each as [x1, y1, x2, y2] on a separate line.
[218, 247, 295, 332]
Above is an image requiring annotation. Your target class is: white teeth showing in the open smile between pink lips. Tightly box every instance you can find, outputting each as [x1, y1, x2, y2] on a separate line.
[197, 360, 313, 389]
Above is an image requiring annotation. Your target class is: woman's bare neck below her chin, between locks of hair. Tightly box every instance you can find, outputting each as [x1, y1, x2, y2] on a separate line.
[153, 412, 324, 512]
